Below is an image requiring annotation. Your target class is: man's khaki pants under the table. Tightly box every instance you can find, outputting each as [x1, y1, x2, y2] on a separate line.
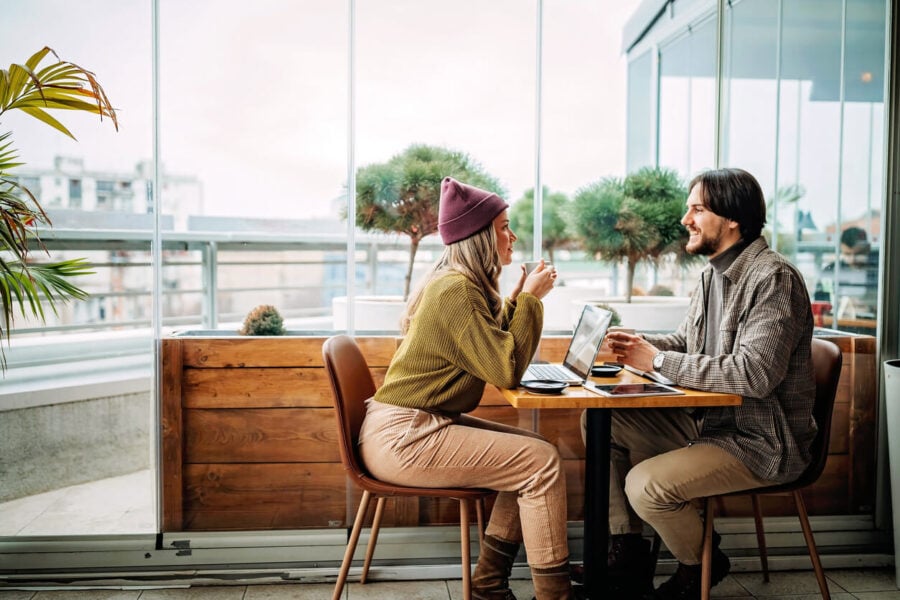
[582, 408, 771, 565]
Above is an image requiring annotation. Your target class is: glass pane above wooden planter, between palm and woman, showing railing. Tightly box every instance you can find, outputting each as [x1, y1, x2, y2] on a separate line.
[157, 0, 349, 332]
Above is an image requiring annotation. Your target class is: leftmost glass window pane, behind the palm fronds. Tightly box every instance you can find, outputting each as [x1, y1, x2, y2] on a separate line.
[0, 0, 157, 540]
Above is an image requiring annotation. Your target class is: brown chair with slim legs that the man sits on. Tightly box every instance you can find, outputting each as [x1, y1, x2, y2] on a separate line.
[700, 338, 843, 600]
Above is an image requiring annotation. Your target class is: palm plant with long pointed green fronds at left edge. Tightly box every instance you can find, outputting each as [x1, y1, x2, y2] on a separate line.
[0, 47, 118, 367]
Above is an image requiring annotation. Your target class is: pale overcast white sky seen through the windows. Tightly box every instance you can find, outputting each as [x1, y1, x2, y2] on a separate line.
[0, 0, 639, 223]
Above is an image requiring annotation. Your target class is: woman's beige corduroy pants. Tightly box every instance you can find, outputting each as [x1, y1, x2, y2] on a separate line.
[359, 400, 569, 568]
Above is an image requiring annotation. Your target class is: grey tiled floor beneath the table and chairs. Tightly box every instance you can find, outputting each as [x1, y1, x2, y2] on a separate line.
[0, 568, 900, 600]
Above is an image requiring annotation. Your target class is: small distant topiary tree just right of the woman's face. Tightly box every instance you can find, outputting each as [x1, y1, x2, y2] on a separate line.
[509, 186, 572, 262]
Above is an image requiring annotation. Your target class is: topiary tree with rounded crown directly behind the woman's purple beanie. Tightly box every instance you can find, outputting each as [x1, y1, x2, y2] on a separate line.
[356, 144, 506, 299]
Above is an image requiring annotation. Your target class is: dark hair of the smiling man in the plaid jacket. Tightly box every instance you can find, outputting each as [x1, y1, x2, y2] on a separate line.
[688, 169, 766, 243]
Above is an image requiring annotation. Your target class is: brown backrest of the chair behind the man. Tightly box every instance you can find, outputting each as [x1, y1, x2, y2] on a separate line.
[791, 338, 843, 488]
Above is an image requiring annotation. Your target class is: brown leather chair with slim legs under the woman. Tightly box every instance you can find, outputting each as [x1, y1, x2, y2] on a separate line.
[322, 335, 494, 600]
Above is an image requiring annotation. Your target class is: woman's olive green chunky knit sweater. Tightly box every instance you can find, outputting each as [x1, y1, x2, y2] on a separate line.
[375, 273, 544, 414]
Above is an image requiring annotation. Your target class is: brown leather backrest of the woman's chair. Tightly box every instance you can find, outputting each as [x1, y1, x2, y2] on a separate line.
[322, 335, 375, 483]
